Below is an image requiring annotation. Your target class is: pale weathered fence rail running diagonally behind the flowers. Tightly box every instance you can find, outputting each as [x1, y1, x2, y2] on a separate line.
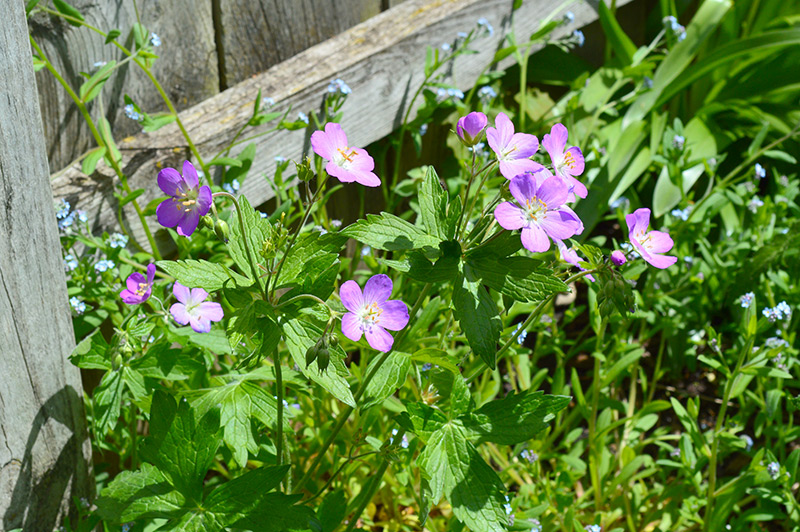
[53, 0, 627, 254]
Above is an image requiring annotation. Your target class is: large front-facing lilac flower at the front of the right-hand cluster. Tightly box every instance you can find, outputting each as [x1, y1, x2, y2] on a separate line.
[494, 168, 583, 252]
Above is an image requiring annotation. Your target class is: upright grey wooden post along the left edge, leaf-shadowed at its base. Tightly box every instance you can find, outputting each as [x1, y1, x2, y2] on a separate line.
[0, 0, 93, 531]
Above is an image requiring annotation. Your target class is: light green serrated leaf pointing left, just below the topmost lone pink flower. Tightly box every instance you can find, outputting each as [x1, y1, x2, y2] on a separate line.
[340, 212, 439, 251]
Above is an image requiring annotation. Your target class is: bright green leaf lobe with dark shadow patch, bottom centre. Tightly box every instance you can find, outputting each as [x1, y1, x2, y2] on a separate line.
[417, 422, 508, 532]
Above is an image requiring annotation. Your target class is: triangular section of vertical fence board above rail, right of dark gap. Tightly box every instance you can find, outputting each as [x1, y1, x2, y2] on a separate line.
[218, 0, 381, 87]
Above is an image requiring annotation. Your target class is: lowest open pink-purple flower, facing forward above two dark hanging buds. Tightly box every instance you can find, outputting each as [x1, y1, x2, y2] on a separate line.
[339, 274, 408, 353]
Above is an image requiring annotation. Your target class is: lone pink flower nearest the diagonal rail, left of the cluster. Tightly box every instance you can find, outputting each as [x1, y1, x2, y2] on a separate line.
[311, 122, 381, 187]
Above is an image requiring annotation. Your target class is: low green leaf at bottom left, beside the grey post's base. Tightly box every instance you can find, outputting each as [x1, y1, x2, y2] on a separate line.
[95, 463, 187, 523]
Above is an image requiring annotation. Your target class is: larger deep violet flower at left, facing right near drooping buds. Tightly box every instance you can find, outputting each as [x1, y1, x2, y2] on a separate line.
[156, 161, 211, 236]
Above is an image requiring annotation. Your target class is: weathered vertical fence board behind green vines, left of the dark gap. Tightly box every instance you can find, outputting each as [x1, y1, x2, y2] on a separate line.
[29, 0, 219, 171]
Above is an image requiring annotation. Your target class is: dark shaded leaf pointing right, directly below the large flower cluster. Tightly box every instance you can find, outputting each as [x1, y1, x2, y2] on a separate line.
[467, 257, 569, 303]
